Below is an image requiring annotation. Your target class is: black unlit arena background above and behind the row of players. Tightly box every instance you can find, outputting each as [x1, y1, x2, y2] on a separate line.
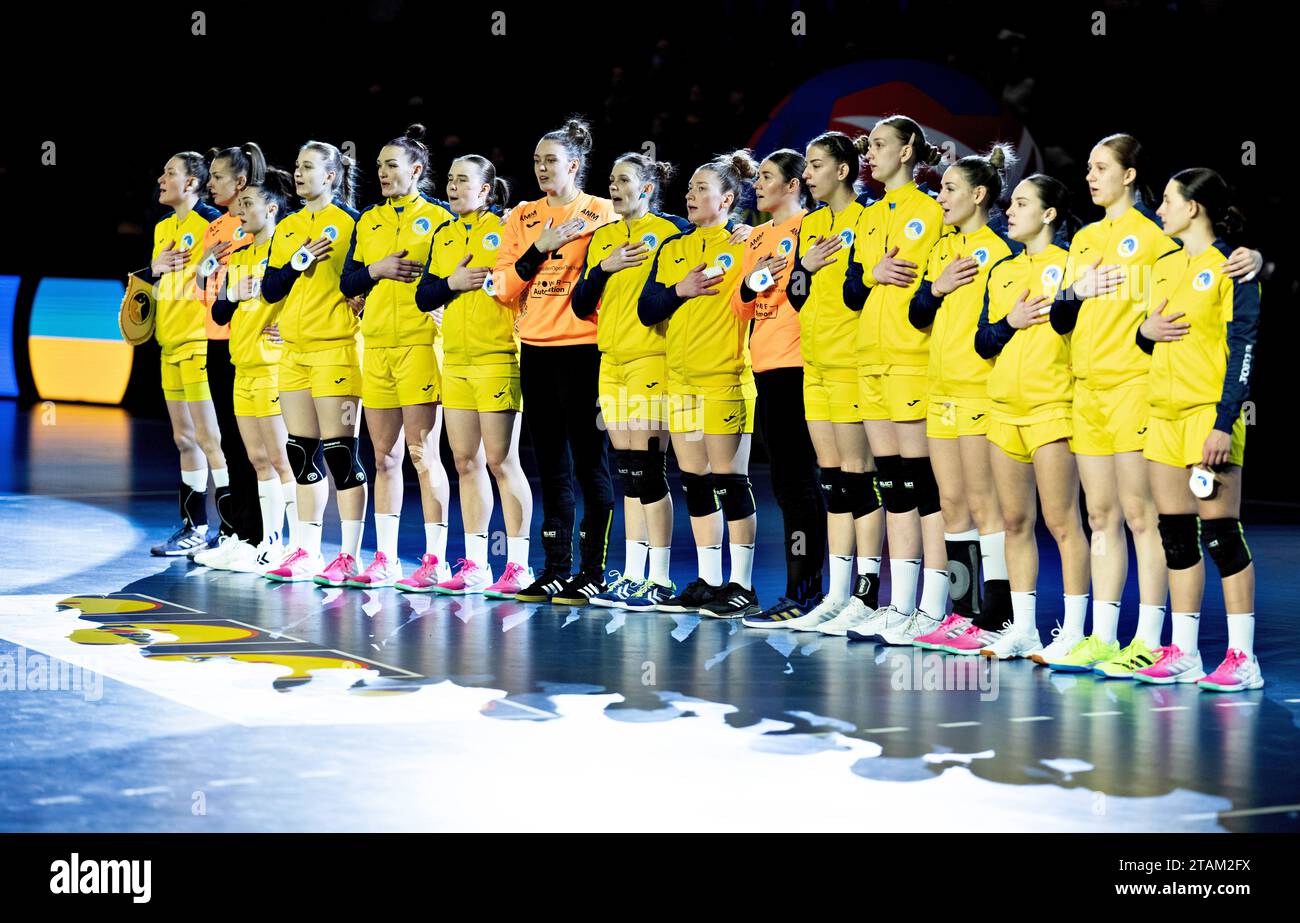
[0, 0, 1300, 519]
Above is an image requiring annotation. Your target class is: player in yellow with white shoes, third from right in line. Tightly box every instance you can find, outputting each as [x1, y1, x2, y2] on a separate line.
[972, 173, 1088, 660]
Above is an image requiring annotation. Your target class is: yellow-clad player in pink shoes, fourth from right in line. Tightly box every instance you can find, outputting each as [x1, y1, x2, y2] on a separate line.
[904, 144, 1021, 654]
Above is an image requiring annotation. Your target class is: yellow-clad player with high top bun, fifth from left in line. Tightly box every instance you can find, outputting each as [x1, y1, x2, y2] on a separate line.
[339, 125, 455, 589]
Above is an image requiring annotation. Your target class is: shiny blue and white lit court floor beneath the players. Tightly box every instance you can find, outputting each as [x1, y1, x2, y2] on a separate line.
[0, 403, 1300, 831]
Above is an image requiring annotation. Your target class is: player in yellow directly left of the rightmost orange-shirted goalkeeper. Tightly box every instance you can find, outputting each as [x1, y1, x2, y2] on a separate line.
[637, 151, 759, 619]
